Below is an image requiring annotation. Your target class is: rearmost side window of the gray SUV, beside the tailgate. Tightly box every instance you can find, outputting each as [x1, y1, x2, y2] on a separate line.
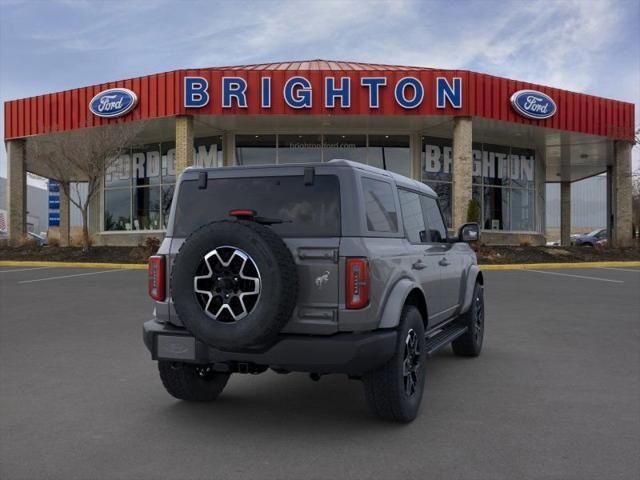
[362, 178, 398, 233]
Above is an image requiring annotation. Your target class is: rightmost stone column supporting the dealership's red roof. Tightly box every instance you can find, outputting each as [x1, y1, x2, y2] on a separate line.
[609, 141, 633, 247]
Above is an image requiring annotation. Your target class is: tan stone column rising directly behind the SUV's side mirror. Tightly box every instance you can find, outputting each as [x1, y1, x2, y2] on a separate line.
[451, 117, 473, 232]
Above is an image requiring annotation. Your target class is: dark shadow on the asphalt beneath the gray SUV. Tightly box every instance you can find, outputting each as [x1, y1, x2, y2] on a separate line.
[149, 353, 461, 438]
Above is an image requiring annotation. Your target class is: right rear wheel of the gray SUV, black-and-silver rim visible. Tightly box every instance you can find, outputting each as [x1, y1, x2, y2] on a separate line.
[362, 305, 426, 422]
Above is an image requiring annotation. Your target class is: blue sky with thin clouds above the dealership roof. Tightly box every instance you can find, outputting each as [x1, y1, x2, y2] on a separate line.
[0, 0, 640, 180]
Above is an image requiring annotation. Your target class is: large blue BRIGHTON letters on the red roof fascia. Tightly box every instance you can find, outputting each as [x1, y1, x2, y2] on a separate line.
[183, 76, 462, 110]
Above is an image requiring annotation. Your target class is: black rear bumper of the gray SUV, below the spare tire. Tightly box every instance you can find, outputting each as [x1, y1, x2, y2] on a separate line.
[143, 320, 397, 375]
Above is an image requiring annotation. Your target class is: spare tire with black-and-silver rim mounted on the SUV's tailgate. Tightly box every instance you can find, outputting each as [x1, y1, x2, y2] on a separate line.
[171, 220, 298, 350]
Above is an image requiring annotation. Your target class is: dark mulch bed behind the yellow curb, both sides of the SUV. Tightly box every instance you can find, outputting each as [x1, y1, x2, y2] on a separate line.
[0, 245, 640, 265]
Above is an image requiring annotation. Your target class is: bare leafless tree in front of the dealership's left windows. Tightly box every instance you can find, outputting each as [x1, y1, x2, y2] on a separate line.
[27, 123, 142, 251]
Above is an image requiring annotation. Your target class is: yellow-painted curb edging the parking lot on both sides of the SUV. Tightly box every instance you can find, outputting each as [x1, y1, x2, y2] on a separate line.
[0, 260, 640, 270]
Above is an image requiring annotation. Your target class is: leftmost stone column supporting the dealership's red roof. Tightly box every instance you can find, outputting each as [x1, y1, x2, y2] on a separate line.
[7, 139, 27, 245]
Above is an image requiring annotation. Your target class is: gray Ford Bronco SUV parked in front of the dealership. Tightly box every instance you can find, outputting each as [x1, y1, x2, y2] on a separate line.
[144, 160, 484, 422]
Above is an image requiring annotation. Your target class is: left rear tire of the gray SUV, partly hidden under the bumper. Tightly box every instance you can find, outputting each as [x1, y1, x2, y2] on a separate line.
[158, 361, 230, 402]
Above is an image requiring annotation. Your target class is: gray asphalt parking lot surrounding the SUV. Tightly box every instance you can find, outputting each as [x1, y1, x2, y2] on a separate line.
[0, 267, 640, 480]
